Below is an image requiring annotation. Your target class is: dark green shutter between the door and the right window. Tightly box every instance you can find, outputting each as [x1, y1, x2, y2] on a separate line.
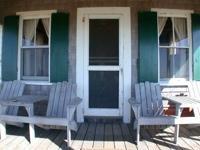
[138, 12, 158, 82]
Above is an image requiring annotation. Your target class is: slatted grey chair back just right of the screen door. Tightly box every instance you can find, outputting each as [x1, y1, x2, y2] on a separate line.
[135, 82, 163, 117]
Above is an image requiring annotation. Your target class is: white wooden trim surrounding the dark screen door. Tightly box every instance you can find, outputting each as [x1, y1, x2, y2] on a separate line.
[76, 7, 131, 123]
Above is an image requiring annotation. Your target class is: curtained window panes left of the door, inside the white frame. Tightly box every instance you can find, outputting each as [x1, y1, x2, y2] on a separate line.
[20, 18, 50, 81]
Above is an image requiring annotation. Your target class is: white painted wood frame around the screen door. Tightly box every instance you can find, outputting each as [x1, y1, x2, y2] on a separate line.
[76, 7, 131, 122]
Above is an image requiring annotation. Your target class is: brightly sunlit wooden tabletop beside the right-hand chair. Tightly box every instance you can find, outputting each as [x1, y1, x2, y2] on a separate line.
[163, 96, 200, 107]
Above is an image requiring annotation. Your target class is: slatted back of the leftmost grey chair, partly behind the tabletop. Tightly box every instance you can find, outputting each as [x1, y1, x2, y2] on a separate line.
[0, 80, 25, 115]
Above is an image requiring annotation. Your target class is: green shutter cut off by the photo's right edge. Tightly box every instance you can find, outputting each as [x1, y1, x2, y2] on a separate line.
[192, 14, 200, 80]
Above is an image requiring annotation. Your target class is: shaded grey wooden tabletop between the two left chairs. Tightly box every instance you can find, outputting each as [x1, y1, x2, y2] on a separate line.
[0, 95, 48, 106]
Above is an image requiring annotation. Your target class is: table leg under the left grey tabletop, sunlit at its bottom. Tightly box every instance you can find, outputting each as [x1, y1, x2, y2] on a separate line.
[26, 105, 35, 143]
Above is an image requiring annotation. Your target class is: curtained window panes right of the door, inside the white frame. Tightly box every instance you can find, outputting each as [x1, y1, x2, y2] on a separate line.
[158, 16, 191, 81]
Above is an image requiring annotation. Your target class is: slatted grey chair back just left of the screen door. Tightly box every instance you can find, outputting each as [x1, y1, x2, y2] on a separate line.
[46, 82, 76, 118]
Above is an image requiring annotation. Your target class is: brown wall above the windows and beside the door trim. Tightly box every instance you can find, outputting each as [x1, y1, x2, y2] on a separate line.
[0, 0, 200, 94]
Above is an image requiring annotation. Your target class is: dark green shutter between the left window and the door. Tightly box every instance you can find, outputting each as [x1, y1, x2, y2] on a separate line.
[50, 13, 69, 82]
